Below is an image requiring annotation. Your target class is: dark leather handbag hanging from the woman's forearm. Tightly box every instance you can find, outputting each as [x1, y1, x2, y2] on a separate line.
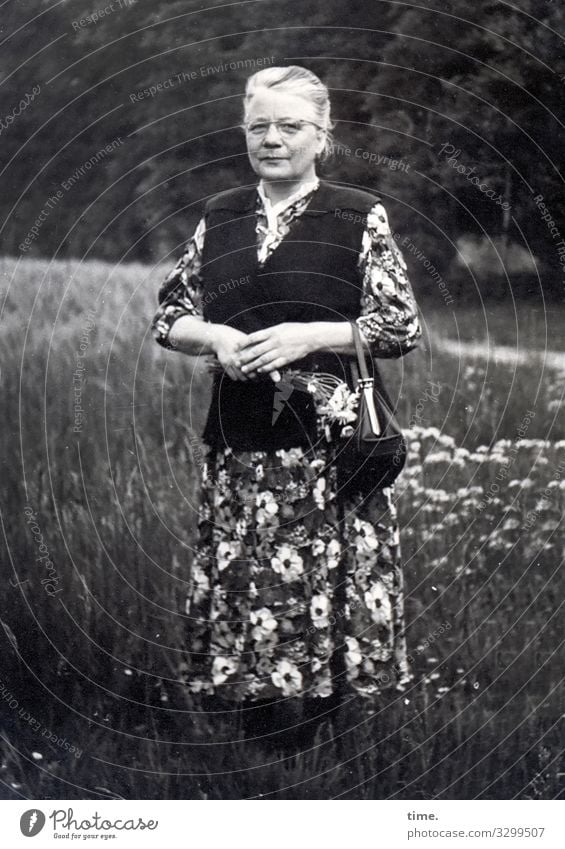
[336, 321, 406, 495]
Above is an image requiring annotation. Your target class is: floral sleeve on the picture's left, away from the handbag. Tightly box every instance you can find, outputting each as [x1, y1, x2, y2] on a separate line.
[151, 218, 206, 348]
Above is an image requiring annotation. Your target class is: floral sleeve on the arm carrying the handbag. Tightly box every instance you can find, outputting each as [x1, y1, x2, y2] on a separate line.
[357, 203, 422, 358]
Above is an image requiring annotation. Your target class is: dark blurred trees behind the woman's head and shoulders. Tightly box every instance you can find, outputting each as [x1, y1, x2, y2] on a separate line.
[0, 0, 565, 302]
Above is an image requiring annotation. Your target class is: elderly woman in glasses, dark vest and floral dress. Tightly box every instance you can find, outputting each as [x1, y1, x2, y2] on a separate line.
[153, 66, 421, 734]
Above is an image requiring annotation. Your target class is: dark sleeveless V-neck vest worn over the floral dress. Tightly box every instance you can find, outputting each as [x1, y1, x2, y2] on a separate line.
[201, 181, 379, 450]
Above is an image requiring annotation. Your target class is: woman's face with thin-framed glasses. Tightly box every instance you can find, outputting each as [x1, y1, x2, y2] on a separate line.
[245, 88, 325, 182]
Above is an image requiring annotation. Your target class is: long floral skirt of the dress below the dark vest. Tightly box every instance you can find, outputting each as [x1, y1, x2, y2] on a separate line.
[181, 446, 413, 701]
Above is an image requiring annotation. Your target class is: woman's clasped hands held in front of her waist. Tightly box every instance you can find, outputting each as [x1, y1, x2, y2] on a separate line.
[208, 322, 313, 382]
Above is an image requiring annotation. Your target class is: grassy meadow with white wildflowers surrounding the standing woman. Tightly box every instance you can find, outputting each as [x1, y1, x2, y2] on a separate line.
[0, 259, 565, 799]
